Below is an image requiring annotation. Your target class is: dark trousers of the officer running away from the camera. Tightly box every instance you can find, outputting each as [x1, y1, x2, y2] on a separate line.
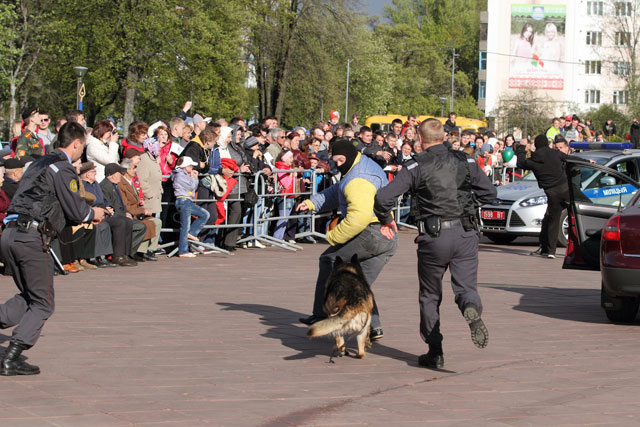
[416, 226, 482, 345]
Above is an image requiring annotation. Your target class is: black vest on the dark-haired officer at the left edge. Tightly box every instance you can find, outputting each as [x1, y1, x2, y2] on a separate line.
[7, 151, 68, 233]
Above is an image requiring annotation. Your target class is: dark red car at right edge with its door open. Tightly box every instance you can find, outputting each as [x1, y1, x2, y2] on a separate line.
[563, 161, 640, 322]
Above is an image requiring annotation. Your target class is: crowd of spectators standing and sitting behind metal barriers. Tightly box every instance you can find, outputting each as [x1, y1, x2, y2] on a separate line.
[0, 103, 636, 273]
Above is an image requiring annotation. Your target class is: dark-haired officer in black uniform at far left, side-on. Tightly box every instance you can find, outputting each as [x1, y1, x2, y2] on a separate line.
[0, 123, 104, 375]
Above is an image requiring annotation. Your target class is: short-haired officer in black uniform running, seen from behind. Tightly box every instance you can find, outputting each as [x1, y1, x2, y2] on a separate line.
[374, 119, 497, 368]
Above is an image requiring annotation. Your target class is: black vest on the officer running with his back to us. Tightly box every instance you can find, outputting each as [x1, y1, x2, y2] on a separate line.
[411, 150, 475, 220]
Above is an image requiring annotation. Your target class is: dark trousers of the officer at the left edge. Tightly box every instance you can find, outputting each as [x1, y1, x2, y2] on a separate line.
[0, 226, 55, 348]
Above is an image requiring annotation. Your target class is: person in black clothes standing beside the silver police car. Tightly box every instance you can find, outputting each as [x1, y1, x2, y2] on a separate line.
[516, 135, 569, 258]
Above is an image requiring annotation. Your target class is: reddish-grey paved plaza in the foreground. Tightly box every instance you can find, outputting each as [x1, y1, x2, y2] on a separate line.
[0, 231, 640, 427]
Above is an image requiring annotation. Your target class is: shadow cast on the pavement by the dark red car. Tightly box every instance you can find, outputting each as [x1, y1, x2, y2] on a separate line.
[478, 283, 640, 324]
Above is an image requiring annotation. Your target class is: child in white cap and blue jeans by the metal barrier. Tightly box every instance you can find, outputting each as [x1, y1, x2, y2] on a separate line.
[171, 156, 209, 258]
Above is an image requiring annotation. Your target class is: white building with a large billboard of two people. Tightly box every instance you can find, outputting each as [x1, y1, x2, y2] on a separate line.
[478, 0, 640, 117]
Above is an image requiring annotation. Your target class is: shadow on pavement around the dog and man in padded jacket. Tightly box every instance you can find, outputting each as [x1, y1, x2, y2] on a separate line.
[218, 302, 428, 366]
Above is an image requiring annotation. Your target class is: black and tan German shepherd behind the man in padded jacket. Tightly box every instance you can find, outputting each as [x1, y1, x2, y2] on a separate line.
[307, 254, 373, 359]
